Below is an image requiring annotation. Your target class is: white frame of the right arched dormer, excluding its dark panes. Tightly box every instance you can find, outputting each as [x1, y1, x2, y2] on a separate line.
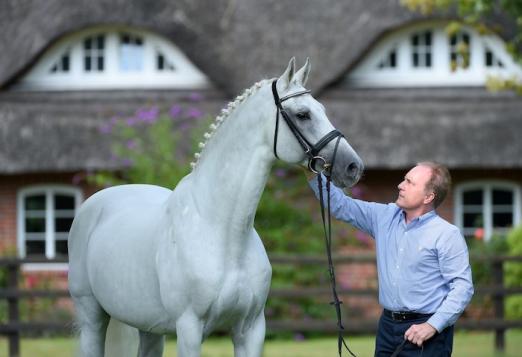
[344, 21, 522, 88]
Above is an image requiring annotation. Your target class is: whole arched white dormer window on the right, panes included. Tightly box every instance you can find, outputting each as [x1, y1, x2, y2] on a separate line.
[346, 22, 522, 87]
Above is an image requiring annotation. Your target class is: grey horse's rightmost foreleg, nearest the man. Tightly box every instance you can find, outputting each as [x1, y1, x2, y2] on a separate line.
[232, 311, 266, 357]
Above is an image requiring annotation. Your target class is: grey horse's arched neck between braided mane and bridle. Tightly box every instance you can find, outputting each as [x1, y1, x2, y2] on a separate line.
[184, 86, 275, 237]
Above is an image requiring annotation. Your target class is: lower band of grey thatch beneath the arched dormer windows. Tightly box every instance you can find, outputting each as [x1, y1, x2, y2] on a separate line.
[0, 88, 522, 173]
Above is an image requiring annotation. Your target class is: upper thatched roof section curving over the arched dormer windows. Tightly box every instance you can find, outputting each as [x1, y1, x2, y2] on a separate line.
[0, 0, 512, 95]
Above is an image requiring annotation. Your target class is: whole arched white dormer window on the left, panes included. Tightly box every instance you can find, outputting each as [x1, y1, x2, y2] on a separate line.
[17, 27, 209, 90]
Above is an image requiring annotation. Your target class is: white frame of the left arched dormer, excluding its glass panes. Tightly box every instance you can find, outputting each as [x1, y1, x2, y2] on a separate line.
[14, 26, 210, 91]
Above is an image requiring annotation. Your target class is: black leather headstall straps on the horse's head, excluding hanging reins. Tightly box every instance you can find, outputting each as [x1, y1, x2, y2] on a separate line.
[272, 79, 343, 173]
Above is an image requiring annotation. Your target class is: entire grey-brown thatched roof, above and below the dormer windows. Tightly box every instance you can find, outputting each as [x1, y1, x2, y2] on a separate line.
[0, 0, 522, 173]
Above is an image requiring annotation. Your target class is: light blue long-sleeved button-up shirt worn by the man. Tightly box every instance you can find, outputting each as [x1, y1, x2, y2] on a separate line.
[310, 179, 473, 332]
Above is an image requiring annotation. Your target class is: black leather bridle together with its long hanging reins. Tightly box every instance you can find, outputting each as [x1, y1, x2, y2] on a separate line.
[272, 80, 355, 357]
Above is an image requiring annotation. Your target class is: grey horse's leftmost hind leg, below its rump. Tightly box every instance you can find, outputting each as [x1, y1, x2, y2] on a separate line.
[73, 296, 109, 357]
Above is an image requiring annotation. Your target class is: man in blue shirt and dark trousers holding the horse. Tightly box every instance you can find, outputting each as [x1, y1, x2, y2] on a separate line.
[308, 162, 473, 357]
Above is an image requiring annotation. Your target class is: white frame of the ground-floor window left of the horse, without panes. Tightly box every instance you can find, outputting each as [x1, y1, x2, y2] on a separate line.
[16, 185, 83, 270]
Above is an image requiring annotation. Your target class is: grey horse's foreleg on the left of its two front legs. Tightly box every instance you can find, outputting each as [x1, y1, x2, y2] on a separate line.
[176, 312, 203, 357]
